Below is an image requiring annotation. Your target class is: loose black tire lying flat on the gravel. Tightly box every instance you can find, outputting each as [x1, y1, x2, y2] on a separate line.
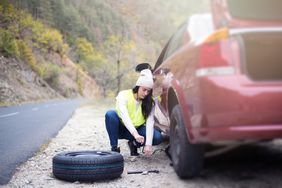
[53, 151, 124, 182]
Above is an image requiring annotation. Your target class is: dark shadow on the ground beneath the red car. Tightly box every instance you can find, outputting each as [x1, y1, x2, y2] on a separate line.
[200, 142, 282, 184]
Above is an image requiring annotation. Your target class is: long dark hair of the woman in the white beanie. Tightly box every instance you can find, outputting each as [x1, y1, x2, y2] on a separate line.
[132, 86, 155, 119]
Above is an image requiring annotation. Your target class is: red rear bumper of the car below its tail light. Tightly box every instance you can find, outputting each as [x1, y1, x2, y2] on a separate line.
[188, 76, 282, 142]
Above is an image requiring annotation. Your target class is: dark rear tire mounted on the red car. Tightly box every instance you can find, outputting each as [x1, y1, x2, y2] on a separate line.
[170, 105, 204, 179]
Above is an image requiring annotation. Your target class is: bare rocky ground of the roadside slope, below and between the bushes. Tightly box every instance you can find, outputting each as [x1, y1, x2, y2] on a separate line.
[0, 56, 99, 106]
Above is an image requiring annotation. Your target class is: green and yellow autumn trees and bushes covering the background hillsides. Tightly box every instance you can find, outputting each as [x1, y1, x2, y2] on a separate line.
[0, 0, 207, 102]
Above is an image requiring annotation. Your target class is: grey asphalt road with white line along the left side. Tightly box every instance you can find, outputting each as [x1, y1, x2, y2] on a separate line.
[0, 100, 80, 185]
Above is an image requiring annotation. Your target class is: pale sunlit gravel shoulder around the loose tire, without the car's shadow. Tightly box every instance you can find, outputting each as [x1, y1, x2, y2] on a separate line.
[4, 105, 187, 188]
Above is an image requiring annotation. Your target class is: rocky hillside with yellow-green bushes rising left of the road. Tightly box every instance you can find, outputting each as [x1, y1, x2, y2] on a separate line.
[0, 1, 100, 106]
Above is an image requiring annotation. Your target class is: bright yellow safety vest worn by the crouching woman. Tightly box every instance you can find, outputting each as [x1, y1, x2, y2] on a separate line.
[116, 89, 146, 127]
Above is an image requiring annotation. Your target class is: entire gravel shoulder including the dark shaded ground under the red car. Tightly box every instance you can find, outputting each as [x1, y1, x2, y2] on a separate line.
[4, 102, 282, 188]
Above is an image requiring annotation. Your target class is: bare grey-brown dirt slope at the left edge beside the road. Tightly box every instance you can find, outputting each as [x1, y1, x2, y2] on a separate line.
[0, 56, 59, 105]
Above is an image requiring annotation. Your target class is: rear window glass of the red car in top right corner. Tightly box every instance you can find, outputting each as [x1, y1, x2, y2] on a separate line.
[227, 0, 282, 21]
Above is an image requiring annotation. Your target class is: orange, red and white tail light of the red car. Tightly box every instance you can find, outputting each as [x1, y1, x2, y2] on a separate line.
[196, 29, 238, 76]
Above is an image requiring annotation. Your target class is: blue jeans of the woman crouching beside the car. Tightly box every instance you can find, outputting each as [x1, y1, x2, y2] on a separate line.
[105, 110, 162, 147]
